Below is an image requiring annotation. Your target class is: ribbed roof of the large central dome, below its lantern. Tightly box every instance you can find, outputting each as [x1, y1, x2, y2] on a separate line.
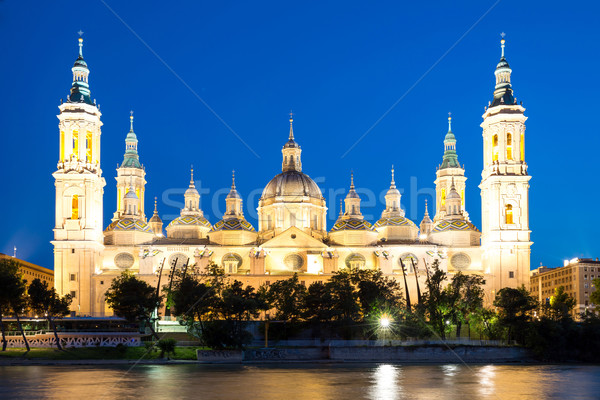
[261, 170, 323, 201]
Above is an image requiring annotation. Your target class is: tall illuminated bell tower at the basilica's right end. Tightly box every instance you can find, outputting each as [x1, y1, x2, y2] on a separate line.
[479, 38, 532, 293]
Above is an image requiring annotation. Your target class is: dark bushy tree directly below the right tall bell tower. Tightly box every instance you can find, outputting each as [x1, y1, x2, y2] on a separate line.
[494, 286, 538, 343]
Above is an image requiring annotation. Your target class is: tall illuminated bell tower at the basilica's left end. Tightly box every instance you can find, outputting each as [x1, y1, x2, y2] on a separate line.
[52, 38, 106, 315]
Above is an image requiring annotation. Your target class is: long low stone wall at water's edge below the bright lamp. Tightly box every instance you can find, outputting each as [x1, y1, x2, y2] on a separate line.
[329, 346, 529, 363]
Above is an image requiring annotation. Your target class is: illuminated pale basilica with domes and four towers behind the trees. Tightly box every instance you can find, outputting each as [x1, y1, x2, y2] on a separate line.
[52, 38, 532, 316]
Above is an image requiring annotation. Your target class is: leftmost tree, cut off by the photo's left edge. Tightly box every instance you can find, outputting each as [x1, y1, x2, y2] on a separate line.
[0, 258, 30, 351]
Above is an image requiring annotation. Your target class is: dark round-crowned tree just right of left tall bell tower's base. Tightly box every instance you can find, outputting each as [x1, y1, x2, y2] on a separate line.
[106, 271, 162, 340]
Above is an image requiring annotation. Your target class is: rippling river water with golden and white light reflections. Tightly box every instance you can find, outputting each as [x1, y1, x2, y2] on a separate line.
[0, 364, 600, 400]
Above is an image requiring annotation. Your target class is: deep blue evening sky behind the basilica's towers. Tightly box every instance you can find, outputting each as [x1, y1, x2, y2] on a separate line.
[0, 0, 600, 267]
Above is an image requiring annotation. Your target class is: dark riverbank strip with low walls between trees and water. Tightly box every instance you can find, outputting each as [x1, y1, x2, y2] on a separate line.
[0, 346, 537, 366]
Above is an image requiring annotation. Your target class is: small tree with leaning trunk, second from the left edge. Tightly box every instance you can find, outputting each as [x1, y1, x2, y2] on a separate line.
[27, 278, 72, 350]
